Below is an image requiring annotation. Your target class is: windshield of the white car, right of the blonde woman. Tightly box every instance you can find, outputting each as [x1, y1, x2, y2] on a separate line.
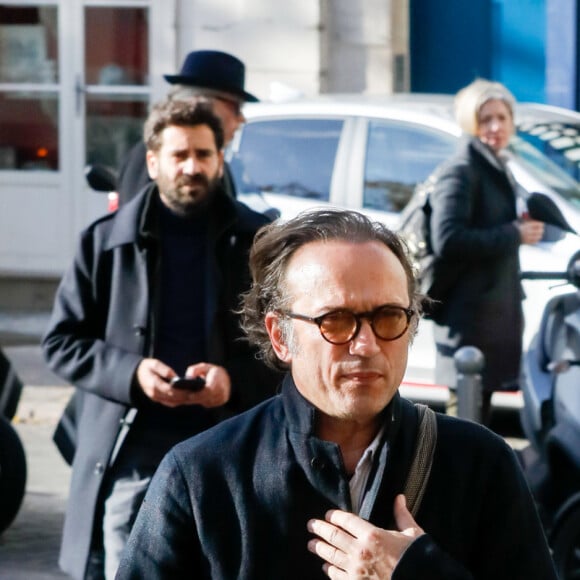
[509, 137, 580, 207]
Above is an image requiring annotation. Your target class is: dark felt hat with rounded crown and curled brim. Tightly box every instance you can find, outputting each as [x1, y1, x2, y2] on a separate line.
[163, 50, 258, 102]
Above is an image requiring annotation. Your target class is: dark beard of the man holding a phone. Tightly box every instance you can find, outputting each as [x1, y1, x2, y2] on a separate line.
[157, 173, 221, 216]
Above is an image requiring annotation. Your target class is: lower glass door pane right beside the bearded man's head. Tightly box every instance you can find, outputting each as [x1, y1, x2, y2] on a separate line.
[86, 95, 149, 168]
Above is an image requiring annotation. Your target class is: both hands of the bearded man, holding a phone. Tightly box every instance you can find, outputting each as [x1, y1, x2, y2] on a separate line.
[136, 358, 231, 408]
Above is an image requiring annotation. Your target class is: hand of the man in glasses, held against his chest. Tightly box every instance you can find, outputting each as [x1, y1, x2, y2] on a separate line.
[308, 494, 425, 580]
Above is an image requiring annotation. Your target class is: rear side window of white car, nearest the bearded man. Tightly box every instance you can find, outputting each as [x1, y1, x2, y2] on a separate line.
[228, 118, 343, 201]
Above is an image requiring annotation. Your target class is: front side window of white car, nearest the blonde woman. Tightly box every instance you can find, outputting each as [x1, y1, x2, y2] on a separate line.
[363, 120, 457, 212]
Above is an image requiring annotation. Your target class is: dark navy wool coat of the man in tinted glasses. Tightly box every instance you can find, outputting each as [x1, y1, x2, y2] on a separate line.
[117, 379, 555, 580]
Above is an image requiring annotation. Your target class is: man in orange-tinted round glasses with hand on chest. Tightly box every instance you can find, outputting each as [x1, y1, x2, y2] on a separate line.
[118, 210, 555, 580]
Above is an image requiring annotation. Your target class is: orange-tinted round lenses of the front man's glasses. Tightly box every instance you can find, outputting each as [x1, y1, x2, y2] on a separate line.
[320, 306, 409, 344]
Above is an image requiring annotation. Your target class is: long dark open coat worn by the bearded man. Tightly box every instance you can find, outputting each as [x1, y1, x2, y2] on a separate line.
[43, 185, 276, 578]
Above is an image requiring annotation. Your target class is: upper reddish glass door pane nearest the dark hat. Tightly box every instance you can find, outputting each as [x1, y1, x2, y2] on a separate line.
[85, 7, 149, 85]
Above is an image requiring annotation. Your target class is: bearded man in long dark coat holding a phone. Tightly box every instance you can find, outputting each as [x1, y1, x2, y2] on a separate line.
[42, 97, 279, 580]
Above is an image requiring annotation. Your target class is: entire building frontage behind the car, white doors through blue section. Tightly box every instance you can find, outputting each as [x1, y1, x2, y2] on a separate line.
[0, 0, 578, 296]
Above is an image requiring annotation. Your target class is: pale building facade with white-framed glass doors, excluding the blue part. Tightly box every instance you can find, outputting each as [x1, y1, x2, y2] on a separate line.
[0, 0, 407, 294]
